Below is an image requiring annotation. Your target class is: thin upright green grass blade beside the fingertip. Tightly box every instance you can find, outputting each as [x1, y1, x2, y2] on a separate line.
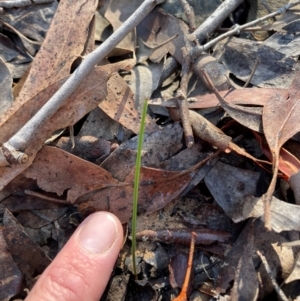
[131, 100, 148, 277]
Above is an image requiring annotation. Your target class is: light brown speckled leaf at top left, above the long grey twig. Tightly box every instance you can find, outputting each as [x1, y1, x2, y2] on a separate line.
[16, 0, 98, 105]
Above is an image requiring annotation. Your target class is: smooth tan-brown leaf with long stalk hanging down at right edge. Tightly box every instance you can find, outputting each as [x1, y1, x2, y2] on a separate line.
[262, 73, 300, 229]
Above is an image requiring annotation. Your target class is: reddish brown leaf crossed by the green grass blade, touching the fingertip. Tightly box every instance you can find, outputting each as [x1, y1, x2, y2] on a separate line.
[76, 167, 194, 223]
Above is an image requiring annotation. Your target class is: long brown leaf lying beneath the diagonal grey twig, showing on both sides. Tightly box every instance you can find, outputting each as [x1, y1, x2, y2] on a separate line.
[0, 63, 123, 188]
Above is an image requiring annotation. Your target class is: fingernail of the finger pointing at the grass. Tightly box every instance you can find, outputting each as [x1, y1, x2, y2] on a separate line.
[78, 212, 117, 254]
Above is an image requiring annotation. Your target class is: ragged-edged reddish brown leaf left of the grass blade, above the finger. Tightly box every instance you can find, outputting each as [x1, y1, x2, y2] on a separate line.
[25, 146, 117, 203]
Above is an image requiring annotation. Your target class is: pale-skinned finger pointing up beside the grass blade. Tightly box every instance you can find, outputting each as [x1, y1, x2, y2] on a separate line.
[25, 212, 123, 301]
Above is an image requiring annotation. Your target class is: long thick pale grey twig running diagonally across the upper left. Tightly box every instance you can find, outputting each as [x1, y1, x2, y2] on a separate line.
[2, 0, 164, 162]
